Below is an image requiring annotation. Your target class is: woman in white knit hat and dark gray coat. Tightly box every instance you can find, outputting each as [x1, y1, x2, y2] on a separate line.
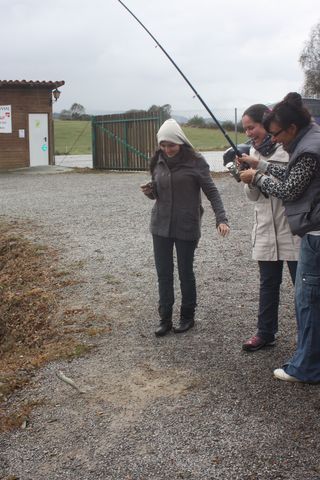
[141, 119, 229, 336]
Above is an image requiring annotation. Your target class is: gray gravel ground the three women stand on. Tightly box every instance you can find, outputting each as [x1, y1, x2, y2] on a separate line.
[0, 172, 320, 480]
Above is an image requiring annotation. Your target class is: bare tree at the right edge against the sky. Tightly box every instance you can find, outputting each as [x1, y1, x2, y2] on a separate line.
[299, 22, 320, 97]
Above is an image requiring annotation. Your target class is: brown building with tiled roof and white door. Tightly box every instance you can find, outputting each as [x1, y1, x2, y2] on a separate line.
[0, 80, 65, 169]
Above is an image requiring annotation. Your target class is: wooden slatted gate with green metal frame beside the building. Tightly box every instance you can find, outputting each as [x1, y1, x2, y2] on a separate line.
[92, 112, 162, 170]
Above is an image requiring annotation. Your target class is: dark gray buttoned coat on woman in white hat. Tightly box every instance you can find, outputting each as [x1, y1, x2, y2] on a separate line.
[150, 153, 228, 240]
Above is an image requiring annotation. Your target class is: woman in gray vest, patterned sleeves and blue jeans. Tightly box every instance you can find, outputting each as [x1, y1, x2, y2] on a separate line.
[238, 92, 320, 383]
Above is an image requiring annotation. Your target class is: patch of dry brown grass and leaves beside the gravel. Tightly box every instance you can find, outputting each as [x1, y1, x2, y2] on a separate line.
[0, 222, 105, 431]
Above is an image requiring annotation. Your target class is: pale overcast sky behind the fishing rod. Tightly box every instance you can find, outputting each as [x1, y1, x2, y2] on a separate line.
[0, 0, 320, 116]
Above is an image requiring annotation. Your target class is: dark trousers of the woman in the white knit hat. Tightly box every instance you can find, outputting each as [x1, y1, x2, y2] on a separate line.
[153, 235, 198, 311]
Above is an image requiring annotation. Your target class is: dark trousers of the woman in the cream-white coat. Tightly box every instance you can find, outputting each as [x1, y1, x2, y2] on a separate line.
[258, 260, 297, 342]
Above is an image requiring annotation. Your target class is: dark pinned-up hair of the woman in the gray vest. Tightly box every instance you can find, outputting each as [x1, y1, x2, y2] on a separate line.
[263, 92, 311, 131]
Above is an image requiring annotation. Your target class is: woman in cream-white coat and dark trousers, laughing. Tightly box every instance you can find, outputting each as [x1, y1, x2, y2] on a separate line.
[242, 104, 300, 352]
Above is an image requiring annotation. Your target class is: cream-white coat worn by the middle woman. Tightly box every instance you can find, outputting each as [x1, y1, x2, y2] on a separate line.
[245, 145, 300, 261]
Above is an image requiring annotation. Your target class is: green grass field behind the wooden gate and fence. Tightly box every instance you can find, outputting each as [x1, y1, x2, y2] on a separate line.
[54, 120, 246, 155]
